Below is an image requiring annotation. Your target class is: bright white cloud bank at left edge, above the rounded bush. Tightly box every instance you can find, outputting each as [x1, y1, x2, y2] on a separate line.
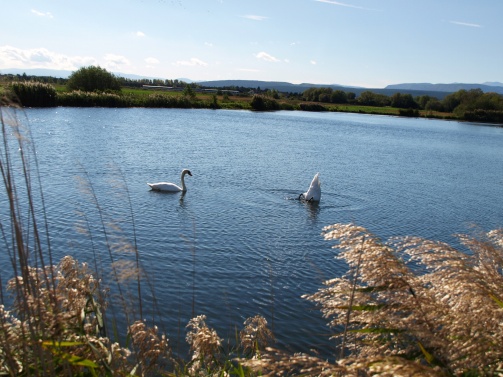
[0, 46, 98, 71]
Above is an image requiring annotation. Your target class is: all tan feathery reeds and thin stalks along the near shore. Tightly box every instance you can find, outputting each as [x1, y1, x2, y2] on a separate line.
[0, 94, 503, 376]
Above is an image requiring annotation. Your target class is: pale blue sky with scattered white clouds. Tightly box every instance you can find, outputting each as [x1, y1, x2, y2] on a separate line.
[0, 0, 503, 88]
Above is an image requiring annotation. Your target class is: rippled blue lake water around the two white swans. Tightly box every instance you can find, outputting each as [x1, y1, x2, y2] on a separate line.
[2, 108, 503, 355]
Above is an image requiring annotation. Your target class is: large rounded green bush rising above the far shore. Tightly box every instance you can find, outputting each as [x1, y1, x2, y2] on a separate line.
[66, 66, 121, 92]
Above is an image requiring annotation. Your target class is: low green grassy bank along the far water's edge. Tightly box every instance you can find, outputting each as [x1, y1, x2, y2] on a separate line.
[3, 83, 460, 119]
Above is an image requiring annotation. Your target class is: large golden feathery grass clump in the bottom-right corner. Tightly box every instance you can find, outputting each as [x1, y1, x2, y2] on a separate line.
[305, 224, 503, 375]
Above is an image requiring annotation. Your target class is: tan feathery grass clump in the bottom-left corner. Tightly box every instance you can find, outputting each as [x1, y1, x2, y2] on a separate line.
[0, 256, 110, 375]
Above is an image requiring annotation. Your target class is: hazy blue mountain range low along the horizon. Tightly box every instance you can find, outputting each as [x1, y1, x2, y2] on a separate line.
[0, 68, 503, 99]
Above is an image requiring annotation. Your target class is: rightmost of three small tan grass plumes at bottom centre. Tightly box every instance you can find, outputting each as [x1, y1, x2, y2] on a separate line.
[239, 315, 274, 357]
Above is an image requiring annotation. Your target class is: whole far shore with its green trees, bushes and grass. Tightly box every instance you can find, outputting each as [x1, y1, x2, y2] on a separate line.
[3, 66, 503, 124]
